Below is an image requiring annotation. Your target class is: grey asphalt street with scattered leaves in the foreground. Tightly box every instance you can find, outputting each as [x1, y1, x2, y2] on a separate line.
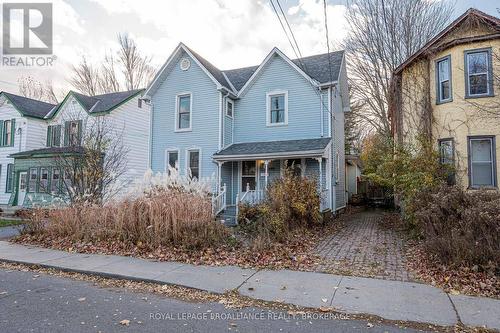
[0, 269, 422, 333]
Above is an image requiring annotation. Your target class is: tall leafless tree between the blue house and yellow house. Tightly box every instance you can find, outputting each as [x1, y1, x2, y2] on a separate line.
[344, 0, 453, 136]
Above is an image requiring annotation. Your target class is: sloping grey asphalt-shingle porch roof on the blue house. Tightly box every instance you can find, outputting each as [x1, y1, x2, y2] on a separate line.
[214, 138, 331, 157]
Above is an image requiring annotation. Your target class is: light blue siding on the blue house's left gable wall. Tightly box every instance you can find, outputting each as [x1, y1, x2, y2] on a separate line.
[151, 52, 220, 177]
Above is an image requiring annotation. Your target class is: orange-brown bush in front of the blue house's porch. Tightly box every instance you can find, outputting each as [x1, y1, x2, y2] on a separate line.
[238, 168, 321, 247]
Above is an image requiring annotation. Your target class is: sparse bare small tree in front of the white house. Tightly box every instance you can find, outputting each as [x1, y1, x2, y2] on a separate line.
[49, 116, 128, 204]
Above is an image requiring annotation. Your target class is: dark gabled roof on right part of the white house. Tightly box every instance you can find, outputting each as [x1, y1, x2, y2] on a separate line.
[45, 89, 144, 119]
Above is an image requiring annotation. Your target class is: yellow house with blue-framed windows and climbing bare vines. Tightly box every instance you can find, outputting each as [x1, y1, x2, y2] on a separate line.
[391, 9, 500, 189]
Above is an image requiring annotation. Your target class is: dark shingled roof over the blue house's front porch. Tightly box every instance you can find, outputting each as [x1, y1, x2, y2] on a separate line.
[213, 138, 331, 161]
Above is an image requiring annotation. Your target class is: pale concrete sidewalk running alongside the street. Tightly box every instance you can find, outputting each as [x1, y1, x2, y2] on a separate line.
[0, 241, 500, 330]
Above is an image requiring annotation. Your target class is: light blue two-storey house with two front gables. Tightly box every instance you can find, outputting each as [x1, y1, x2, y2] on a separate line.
[145, 43, 350, 220]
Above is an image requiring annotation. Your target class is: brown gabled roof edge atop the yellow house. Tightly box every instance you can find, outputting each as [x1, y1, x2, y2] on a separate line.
[394, 8, 500, 74]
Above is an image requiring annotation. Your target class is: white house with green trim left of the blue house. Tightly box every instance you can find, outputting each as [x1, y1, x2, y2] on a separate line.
[0, 90, 150, 207]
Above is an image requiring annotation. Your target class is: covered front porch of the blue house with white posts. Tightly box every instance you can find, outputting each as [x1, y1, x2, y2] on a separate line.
[213, 138, 332, 217]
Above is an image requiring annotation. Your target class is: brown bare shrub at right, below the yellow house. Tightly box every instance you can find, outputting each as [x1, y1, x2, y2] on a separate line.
[414, 186, 500, 274]
